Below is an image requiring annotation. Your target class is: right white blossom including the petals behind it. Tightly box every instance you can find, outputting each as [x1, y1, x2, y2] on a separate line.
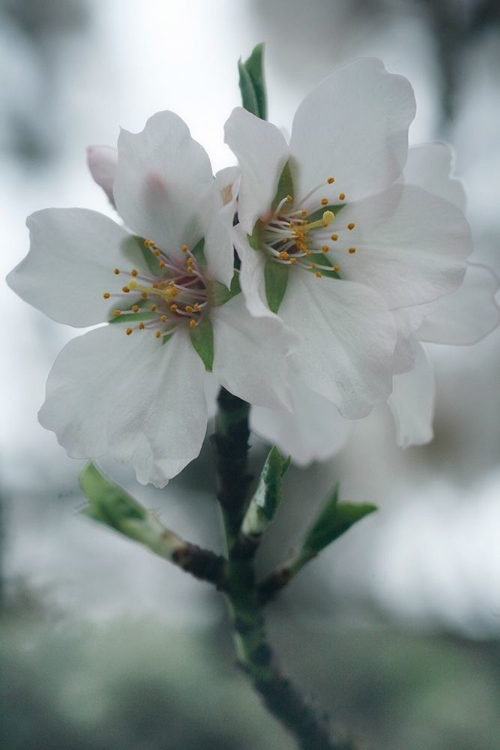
[226, 59, 498, 464]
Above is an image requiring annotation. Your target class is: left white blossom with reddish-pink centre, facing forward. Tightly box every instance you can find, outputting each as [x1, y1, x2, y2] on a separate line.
[8, 112, 291, 487]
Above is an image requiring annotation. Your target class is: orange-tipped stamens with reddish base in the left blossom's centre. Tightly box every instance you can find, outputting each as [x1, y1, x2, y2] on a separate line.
[103, 240, 208, 339]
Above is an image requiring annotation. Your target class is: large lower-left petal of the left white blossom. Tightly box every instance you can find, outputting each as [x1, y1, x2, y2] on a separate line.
[39, 326, 207, 487]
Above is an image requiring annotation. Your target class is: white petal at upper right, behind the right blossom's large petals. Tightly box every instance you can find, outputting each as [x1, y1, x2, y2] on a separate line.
[404, 143, 466, 211]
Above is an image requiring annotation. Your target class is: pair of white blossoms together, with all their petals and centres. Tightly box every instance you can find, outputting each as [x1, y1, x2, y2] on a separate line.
[9, 59, 499, 486]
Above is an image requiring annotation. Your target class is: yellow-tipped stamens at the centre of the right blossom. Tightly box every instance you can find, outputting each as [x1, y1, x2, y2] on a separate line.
[259, 177, 356, 277]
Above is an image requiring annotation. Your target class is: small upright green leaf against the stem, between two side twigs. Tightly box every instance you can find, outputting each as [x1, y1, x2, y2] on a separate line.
[241, 445, 289, 536]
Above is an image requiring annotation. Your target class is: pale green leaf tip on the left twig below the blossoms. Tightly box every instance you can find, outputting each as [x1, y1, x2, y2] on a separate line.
[79, 463, 147, 531]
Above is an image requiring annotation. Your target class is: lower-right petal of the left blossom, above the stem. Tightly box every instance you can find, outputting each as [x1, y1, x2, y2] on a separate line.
[211, 294, 297, 409]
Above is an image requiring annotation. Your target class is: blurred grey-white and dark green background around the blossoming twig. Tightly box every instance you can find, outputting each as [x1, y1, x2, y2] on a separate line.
[0, 0, 500, 750]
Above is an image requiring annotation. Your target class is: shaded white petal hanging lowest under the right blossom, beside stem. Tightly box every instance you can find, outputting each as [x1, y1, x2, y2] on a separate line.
[250, 378, 351, 467]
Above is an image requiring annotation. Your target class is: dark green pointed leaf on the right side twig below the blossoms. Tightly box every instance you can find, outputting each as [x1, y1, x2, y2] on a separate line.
[301, 485, 377, 557]
